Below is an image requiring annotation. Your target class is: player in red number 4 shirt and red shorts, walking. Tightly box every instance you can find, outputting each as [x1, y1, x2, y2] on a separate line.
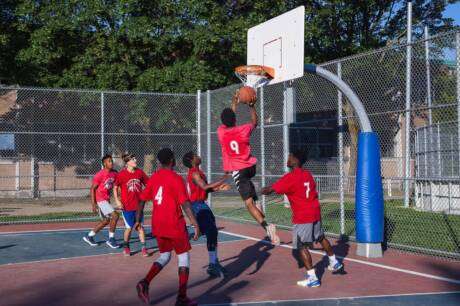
[135, 148, 200, 306]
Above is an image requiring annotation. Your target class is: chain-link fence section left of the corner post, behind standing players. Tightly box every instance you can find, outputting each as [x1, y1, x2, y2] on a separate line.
[0, 88, 197, 224]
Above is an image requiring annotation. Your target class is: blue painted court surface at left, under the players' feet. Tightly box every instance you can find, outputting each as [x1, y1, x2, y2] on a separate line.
[0, 228, 244, 265]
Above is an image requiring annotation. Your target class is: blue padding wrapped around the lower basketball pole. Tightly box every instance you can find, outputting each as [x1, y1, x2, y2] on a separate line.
[355, 132, 384, 243]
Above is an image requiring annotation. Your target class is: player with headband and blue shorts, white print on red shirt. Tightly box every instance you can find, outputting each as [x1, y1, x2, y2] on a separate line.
[114, 154, 149, 257]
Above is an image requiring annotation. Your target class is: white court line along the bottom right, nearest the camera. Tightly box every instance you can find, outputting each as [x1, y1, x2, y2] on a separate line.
[201, 291, 460, 306]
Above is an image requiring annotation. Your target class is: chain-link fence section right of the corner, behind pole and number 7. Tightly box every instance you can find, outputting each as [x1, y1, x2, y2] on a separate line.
[207, 32, 460, 258]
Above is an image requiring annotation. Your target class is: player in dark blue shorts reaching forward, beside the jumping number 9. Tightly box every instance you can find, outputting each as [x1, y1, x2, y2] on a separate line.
[182, 152, 230, 277]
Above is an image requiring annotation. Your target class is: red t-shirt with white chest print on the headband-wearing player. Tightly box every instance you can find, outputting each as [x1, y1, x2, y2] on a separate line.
[115, 168, 149, 211]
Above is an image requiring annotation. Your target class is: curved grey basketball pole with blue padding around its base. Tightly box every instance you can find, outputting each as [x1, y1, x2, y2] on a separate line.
[304, 64, 384, 257]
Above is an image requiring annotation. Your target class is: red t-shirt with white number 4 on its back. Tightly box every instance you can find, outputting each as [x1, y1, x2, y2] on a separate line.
[141, 169, 188, 238]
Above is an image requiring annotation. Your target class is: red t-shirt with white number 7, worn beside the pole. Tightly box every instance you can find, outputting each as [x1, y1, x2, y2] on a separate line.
[272, 168, 321, 224]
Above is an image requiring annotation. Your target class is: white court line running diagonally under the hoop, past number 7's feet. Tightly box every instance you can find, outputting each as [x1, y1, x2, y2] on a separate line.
[220, 231, 460, 285]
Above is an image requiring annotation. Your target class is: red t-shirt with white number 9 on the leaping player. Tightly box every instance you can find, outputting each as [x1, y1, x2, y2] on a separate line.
[217, 123, 257, 171]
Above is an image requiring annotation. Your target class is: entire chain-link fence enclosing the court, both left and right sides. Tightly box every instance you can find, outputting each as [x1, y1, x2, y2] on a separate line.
[0, 32, 460, 257]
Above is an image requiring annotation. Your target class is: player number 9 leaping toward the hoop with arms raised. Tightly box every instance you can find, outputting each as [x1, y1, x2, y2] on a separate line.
[217, 94, 279, 244]
